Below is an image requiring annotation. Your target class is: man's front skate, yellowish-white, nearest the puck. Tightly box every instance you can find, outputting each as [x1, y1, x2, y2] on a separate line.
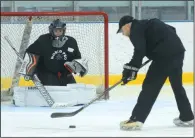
[120, 120, 143, 131]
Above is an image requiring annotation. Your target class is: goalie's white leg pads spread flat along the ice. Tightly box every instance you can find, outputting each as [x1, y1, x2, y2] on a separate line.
[13, 83, 96, 108]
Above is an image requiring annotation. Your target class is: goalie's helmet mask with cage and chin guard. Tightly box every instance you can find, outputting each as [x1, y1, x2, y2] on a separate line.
[49, 19, 68, 48]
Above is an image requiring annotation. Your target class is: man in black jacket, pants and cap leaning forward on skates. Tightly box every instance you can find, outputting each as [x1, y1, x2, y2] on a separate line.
[117, 16, 194, 130]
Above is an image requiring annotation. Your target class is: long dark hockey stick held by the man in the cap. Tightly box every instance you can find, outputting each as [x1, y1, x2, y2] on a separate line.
[51, 60, 151, 118]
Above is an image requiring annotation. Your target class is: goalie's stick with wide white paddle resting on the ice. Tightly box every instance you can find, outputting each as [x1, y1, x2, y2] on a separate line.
[4, 36, 72, 108]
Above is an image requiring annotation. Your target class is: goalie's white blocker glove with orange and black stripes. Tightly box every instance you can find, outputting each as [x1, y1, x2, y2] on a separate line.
[19, 53, 40, 80]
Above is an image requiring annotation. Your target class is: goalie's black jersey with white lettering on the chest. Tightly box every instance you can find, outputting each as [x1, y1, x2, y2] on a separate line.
[26, 34, 81, 74]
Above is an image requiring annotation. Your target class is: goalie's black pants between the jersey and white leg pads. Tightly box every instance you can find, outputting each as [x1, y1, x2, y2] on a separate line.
[37, 71, 76, 86]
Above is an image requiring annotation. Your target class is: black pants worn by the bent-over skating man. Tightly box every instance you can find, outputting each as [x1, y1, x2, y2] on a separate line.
[130, 53, 194, 123]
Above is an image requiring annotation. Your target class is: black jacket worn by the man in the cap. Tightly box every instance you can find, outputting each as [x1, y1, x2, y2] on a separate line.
[129, 18, 185, 68]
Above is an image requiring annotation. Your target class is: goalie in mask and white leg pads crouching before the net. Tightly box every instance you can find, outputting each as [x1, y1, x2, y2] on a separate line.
[14, 19, 95, 106]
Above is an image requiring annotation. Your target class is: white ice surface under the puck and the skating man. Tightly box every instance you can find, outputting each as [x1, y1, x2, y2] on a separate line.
[1, 85, 194, 137]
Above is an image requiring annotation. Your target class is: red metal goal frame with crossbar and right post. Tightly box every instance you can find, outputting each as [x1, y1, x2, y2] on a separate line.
[1, 11, 109, 99]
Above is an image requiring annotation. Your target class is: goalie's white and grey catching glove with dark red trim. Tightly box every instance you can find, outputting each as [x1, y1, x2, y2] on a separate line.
[64, 59, 88, 77]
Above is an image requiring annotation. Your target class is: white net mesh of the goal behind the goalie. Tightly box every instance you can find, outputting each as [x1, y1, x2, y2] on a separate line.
[1, 12, 109, 101]
